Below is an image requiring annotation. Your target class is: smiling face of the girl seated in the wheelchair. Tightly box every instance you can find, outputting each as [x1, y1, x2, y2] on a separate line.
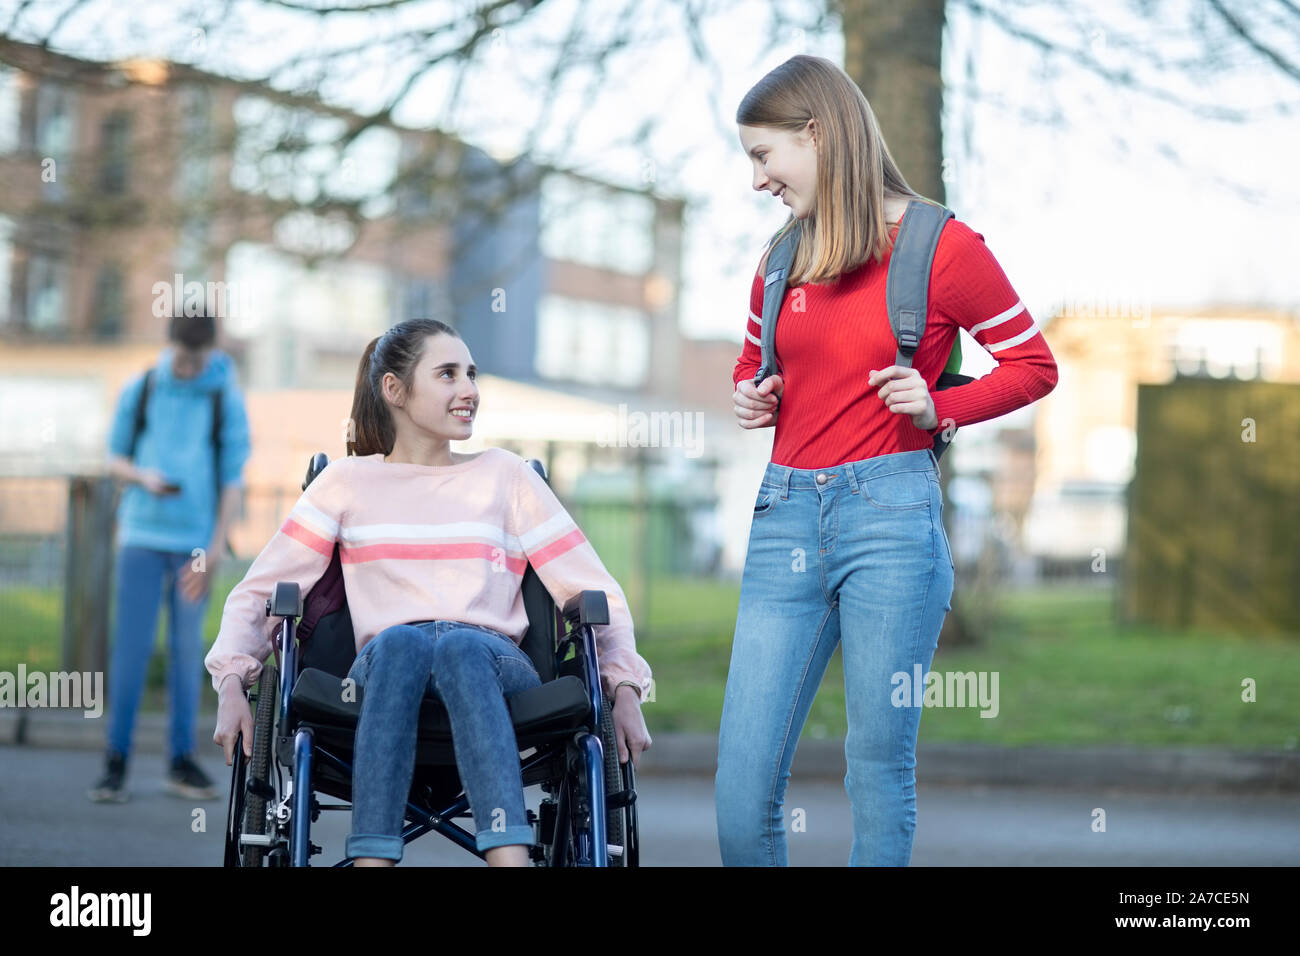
[384, 336, 478, 444]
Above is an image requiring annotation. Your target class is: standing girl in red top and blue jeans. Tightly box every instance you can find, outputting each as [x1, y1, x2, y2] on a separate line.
[715, 56, 1057, 866]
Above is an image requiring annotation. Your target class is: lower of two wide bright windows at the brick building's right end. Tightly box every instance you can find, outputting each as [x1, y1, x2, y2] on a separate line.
[536, 295, 650, 389]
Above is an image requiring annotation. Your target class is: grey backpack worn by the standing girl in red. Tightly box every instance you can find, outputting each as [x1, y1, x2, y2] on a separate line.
[754, 199, 975, 460]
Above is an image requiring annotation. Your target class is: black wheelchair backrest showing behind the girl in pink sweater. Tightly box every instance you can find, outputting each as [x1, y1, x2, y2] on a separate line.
[296, 453, 560, 683]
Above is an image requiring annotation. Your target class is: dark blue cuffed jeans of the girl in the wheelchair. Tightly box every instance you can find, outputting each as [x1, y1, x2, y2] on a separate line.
[346, 620, 542, 860]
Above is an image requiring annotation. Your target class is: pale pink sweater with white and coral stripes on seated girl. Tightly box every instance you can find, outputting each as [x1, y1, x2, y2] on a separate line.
[204, 447, 650, 700]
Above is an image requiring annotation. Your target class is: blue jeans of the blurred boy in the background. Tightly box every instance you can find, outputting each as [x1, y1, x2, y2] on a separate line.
[108, 546, 211, 758]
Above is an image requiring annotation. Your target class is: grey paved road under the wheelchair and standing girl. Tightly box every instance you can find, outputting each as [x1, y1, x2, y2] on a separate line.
[0, 747, 1300, 866]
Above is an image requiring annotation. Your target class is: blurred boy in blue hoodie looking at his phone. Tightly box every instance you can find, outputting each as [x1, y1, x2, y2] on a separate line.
[87, 315, 250, 803]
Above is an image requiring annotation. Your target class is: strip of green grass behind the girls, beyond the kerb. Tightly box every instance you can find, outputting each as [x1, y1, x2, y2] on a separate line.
[0, 575, 1300, 748]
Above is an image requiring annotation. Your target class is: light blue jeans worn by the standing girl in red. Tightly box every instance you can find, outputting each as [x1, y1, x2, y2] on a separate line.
[715, 449, 953, 866]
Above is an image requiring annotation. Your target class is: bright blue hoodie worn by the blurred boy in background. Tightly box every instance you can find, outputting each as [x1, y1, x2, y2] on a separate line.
[108, 347, 251, 554]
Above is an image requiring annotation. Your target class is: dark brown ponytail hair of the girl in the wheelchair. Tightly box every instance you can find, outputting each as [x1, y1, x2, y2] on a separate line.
[347, 319, 460, 455]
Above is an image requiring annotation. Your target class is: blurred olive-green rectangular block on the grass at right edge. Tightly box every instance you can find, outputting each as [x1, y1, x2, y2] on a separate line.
[1121, 377, 1300, 635]
